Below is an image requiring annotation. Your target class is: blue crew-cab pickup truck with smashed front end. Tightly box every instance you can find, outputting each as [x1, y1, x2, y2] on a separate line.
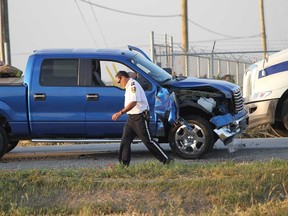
[0, 46, 247, 159]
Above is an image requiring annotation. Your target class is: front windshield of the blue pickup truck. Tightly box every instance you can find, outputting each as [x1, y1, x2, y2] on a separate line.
[132, 55, 172, 84]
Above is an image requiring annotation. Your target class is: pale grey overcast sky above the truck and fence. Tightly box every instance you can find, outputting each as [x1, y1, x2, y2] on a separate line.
[8, 0, 288, 71]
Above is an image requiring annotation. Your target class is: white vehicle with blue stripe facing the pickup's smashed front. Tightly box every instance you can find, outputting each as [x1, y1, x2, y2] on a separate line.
[243, 49, 288, 137]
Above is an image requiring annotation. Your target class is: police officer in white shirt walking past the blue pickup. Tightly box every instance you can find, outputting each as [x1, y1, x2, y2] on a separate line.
[112, 71, 171, 166]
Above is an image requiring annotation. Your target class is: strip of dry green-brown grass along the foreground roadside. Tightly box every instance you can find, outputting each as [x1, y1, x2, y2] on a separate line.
[0, 160, 288, 215]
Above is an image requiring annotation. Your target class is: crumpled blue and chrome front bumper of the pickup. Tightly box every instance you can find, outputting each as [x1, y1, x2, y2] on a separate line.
[210, 109, 248, 145]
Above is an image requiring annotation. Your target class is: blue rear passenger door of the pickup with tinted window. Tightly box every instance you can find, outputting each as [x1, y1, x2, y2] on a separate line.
[28, 59, 86, 137]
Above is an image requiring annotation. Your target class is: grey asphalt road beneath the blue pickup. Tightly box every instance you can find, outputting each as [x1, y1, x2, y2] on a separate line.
[0, 138, 288, 170]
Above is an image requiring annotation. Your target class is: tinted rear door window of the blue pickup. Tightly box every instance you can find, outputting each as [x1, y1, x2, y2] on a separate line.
[40, 59, 79, 86]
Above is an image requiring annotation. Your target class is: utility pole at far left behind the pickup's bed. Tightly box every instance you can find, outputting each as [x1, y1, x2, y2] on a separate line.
[0, 0, 11, 65]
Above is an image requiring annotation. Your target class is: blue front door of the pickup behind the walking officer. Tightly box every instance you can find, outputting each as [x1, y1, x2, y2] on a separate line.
[86, 59, 155, 138]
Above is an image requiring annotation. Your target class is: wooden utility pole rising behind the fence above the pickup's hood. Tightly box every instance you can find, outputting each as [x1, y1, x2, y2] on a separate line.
[182, 0, 189, 76]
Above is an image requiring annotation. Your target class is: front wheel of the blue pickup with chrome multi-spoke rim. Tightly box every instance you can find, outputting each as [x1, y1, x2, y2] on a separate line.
[169, 116, 215, 159]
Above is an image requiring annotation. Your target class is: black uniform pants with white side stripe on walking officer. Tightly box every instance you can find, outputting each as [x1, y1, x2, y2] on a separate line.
[119, 113, 169, 166]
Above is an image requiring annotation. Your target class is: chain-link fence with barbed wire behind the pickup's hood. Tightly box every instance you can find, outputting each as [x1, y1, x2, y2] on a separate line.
[150, 32, 278, 86]
